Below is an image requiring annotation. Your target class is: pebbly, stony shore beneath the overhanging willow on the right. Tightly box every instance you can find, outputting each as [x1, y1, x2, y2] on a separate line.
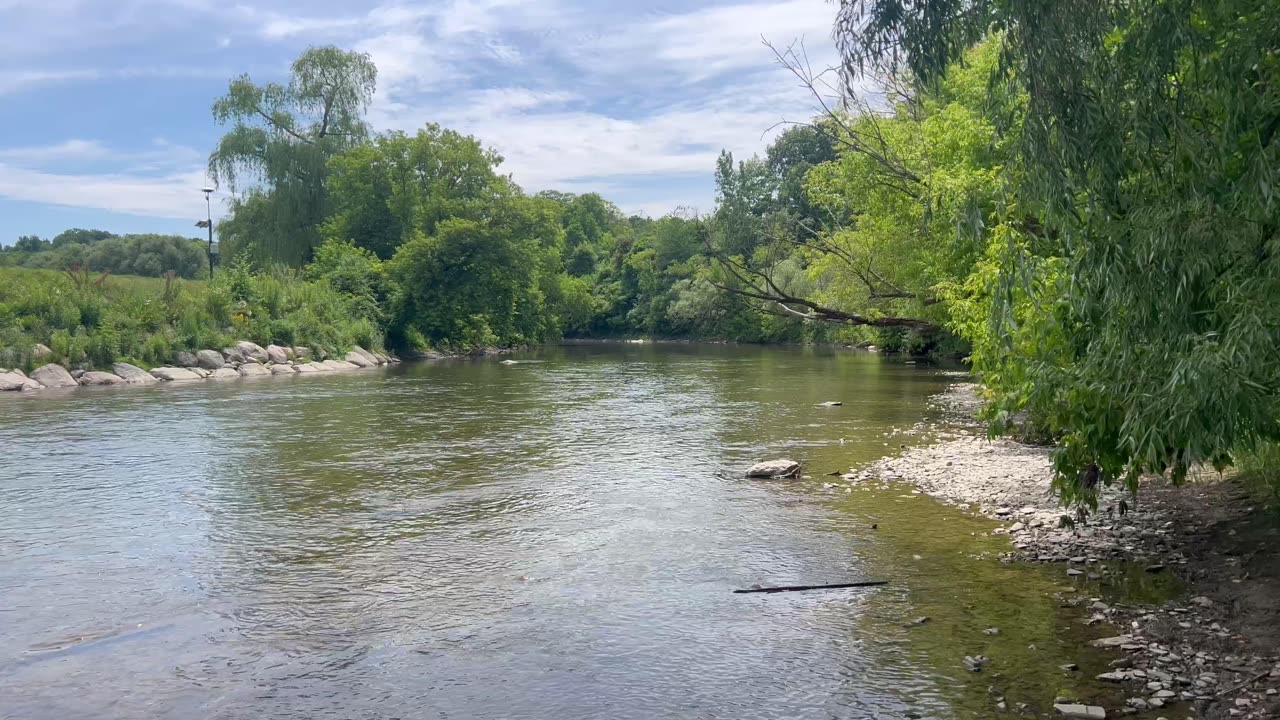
[844, 386, 1280, 720]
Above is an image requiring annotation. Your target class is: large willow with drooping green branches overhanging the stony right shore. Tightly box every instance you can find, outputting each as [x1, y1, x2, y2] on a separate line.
[836, 0, 1280, 506]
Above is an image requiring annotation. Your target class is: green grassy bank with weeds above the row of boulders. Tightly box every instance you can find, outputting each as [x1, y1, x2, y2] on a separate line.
[0, 266, 383, 370]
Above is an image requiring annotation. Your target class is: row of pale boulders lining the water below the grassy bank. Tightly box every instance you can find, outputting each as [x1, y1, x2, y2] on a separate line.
[0, 341, 399, 391]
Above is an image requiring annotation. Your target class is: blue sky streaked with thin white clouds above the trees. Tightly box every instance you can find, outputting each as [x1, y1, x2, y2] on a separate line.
[0, 0, 836, 245]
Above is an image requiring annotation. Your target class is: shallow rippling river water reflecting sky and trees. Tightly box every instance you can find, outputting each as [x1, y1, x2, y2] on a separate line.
[0, 345, 1141, 719]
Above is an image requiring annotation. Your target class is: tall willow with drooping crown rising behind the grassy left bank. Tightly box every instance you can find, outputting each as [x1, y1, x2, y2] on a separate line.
[209, 46, 378, 265]
